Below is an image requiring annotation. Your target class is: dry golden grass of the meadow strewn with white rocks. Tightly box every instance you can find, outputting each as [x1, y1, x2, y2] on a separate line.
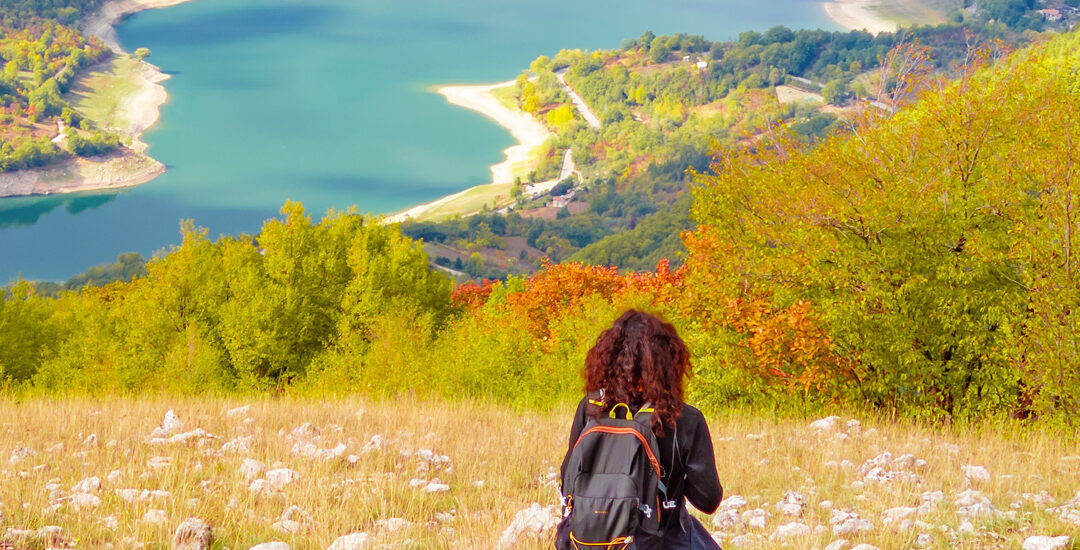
[0, 398, 1080, 549]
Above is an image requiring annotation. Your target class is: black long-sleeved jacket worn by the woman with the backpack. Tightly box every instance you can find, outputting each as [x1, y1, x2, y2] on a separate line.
[559, 398, 724, 532]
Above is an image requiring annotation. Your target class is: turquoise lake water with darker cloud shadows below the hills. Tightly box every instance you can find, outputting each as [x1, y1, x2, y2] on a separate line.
[0, 0, 837, 282]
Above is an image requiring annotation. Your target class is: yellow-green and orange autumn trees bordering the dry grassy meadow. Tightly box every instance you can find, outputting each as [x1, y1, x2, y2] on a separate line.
[0, 32, 1080, 426]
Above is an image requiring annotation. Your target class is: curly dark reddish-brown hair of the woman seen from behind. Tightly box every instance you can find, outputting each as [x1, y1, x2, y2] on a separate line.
[584, 309, 690, 437]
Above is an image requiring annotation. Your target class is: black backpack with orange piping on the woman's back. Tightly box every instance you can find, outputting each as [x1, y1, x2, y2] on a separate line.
[563, 400, 666, 550]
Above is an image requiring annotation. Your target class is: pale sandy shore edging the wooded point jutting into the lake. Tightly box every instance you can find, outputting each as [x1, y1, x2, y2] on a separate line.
[384, 80, 553, 224]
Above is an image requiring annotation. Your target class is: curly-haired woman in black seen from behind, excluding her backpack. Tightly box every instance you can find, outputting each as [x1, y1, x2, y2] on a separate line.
[559, 310, 724, 550]
